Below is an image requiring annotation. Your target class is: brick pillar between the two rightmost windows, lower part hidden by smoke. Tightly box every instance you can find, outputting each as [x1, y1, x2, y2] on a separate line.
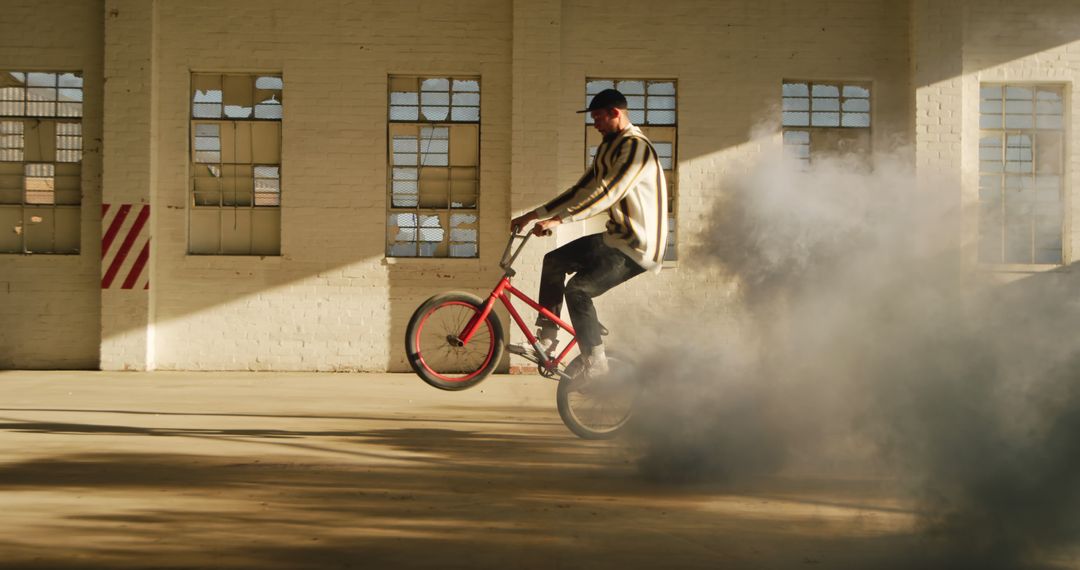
[912, 0, 975, 251]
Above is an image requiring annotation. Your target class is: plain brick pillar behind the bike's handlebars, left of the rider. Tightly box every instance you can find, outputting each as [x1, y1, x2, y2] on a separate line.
[504, 0, 565, 370]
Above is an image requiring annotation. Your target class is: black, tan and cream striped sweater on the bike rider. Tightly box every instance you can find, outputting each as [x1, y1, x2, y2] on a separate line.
[536, 125, 667, 271]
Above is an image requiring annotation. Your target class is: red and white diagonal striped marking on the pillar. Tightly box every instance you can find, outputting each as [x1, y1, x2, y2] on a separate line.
[102, 204, 150, 289]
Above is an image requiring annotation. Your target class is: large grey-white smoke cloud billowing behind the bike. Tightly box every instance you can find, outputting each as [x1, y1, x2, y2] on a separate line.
[617, 137, 1080, 569]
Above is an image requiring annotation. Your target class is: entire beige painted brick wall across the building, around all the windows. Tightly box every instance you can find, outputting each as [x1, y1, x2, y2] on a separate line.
[0, 0, 1080, 370]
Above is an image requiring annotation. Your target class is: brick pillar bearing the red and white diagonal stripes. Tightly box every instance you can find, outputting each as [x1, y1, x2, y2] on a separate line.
[100, 0, 157, 370]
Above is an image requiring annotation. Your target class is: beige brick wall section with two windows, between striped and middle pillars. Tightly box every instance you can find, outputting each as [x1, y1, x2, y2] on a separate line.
[142, 0, 511, 370]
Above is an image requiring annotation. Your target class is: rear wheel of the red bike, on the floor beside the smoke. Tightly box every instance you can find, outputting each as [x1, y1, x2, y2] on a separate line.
[556, 354, 642, 439]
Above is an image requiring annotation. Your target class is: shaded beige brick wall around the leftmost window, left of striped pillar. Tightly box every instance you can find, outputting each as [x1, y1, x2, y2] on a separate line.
[0, 0, 104, 368]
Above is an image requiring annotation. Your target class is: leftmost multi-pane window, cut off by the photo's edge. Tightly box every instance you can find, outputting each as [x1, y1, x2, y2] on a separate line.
[0, 71, 83, 254]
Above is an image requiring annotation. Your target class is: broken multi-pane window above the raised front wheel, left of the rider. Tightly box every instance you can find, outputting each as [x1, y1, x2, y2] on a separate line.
[387, 77, 480, 257]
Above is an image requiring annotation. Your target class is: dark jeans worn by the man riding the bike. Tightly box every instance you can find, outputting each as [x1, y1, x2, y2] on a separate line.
[537, 233, 645, 353]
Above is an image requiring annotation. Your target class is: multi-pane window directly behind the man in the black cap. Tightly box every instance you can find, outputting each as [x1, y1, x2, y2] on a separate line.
[584, 79, 678, 261]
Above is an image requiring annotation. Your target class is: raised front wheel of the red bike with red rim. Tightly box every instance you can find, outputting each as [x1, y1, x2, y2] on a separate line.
[405, 293, 504, 390]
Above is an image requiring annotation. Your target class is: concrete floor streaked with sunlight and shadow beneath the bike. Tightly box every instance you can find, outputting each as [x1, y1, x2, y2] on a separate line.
[0, 371, 918, 569]
